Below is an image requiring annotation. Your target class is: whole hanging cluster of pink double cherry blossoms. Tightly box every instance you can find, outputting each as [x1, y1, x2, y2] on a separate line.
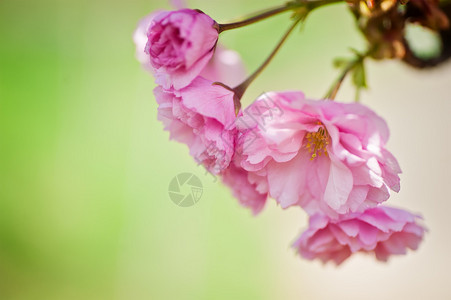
[134, 5, 425, 264]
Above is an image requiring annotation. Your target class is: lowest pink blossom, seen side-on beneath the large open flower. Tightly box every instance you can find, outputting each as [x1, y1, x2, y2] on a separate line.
[293, 206, 426, 265]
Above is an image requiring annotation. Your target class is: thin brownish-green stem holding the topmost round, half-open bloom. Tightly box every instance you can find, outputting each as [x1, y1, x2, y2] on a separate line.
[217, 0, 344, 33]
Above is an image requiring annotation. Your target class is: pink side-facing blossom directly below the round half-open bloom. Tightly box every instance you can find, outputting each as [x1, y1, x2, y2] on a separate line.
[154, 77, 236, 174]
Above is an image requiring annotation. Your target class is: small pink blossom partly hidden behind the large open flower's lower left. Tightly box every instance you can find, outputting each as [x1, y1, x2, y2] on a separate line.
[222, 162, 268, 215]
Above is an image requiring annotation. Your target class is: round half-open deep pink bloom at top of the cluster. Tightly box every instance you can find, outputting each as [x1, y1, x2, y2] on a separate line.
[144, 9, 218, 90]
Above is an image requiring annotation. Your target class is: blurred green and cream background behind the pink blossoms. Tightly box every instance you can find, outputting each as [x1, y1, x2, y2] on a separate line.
[0, 0, 451, 300]
